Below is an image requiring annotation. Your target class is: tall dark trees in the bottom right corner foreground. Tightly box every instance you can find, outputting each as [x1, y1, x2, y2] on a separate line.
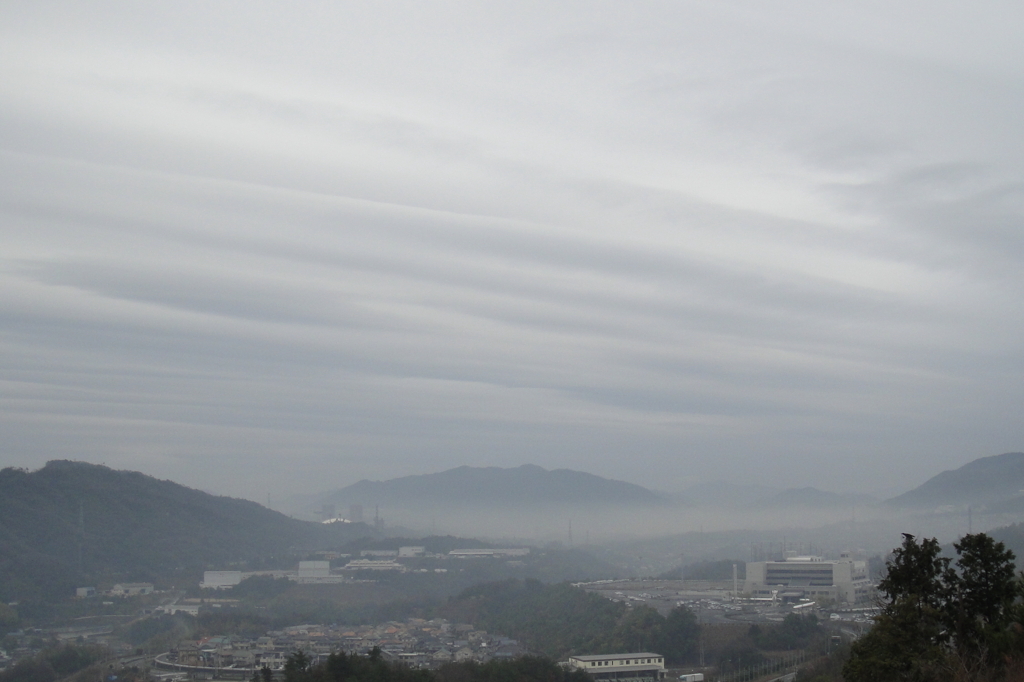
[843, 534, 1024, 682]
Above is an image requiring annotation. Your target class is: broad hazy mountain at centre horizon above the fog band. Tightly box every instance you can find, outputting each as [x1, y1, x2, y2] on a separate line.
[326, 464, 663, 509]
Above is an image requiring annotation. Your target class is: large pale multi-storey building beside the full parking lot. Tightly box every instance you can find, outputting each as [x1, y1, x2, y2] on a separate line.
[743, 554, 871, 604]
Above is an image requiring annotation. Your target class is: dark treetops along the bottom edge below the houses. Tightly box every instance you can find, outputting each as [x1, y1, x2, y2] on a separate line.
[268, 648, 589, 682]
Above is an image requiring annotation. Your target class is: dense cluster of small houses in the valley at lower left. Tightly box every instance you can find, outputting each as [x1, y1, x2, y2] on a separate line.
[157, 619, 525, 672]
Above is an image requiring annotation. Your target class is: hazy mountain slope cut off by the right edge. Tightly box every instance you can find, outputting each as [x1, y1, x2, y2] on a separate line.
[887, 453, 1024, 509]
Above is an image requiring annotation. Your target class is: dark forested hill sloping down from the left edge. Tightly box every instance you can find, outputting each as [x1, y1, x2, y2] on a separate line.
[0, 461, 374, 601]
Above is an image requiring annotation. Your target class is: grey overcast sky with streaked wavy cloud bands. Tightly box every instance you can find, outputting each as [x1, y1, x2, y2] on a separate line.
[0, 0, 1024, 501]
